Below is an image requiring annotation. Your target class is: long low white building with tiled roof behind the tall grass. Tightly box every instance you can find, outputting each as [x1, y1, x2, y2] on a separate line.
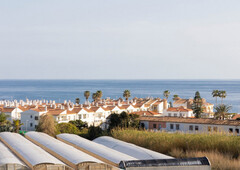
[140, 116, 240, 135]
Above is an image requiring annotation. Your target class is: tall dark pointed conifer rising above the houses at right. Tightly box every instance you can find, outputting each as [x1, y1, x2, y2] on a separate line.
[192, 91, 203, 118]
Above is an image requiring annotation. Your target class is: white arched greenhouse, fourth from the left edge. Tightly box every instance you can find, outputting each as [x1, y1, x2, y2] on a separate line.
[57, 134, 137, 167]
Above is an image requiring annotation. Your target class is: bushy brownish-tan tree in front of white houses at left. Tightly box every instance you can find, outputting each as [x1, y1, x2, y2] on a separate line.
[36, 114, 57, 136]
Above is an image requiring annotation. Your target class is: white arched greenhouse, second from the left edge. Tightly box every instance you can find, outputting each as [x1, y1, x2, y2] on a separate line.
[0, 132, 68, 170]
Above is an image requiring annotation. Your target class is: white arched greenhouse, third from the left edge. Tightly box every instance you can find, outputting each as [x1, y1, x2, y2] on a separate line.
[26, 132, 113, 170]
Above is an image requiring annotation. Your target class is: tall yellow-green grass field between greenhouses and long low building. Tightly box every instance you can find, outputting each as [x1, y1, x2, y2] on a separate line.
[112, 129, 240, 169]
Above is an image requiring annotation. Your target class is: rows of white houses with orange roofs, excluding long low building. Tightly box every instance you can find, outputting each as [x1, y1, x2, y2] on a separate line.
[0, 98, 217, 131]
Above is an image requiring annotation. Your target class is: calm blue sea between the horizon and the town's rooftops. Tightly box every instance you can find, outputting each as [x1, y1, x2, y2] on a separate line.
[0, 80, 240, 113]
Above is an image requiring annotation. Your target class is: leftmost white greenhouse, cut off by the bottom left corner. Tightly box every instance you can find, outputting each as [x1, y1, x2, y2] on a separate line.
[0, 142, 29, 170]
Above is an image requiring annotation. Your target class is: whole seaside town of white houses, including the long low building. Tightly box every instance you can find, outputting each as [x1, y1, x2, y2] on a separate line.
[0, 90, 240, 135]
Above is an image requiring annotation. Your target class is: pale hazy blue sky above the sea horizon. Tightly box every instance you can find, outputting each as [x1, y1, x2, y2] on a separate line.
[0, 0, 240, 79]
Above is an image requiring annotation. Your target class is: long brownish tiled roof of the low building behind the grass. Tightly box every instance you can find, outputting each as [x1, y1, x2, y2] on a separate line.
[140, 116, 240, 126]
